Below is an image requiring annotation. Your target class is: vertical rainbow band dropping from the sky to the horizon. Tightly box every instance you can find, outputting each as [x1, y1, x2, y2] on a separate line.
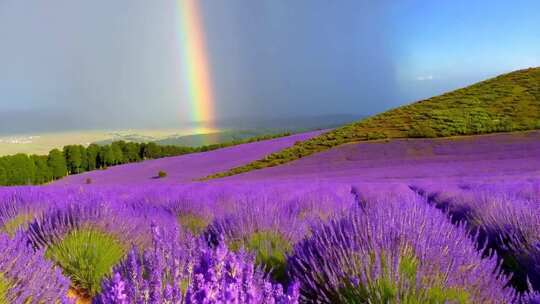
[176, 0, 215, 133]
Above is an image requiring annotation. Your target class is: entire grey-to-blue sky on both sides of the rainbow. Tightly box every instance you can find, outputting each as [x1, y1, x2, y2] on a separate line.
[0, 0, 540, 132]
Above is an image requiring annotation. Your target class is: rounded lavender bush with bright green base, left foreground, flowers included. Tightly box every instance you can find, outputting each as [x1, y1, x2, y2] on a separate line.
[27, 201, 167, 296]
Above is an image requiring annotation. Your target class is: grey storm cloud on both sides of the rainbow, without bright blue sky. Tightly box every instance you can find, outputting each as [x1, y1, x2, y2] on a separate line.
[0, 0, 392, 133]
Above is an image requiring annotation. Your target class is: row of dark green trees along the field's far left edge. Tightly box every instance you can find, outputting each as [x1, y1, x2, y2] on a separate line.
[0, 133, 290, 186]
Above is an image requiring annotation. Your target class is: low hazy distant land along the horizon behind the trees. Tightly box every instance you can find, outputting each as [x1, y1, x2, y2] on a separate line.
[0, 106, 362, 136]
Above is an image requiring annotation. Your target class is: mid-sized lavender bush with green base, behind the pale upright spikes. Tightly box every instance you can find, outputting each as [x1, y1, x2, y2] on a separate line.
[202, 184, 355, 283]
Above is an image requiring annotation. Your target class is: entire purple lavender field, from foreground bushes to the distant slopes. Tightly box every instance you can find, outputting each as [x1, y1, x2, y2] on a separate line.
[0, 132, 540, 303]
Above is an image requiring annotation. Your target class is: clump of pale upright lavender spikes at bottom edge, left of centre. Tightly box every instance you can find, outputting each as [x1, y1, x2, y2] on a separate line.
[95, 227, 298, 304]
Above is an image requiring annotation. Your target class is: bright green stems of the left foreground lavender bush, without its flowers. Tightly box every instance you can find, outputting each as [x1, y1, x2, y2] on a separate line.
[45, 228, 127, 297]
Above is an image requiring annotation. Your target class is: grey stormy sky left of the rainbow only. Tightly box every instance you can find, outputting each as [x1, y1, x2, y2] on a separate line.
[0, 0, 181, 129]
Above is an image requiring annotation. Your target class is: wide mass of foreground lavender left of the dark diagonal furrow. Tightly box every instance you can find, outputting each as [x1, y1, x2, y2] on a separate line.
[0, 182, 534, 303]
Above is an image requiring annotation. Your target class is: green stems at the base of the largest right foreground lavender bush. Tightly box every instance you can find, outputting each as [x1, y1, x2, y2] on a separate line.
[340, 252, 471, 304]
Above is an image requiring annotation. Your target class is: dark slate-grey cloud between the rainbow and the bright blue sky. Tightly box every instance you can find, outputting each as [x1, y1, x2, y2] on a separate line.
[204, 0, 395, 120]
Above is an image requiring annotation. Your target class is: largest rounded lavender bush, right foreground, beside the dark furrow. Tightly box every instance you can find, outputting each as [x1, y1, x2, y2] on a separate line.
[289, 196, 516, 303]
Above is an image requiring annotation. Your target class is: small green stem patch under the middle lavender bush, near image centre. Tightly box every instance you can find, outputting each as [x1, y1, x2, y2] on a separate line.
[228, 231, 292, 282]
